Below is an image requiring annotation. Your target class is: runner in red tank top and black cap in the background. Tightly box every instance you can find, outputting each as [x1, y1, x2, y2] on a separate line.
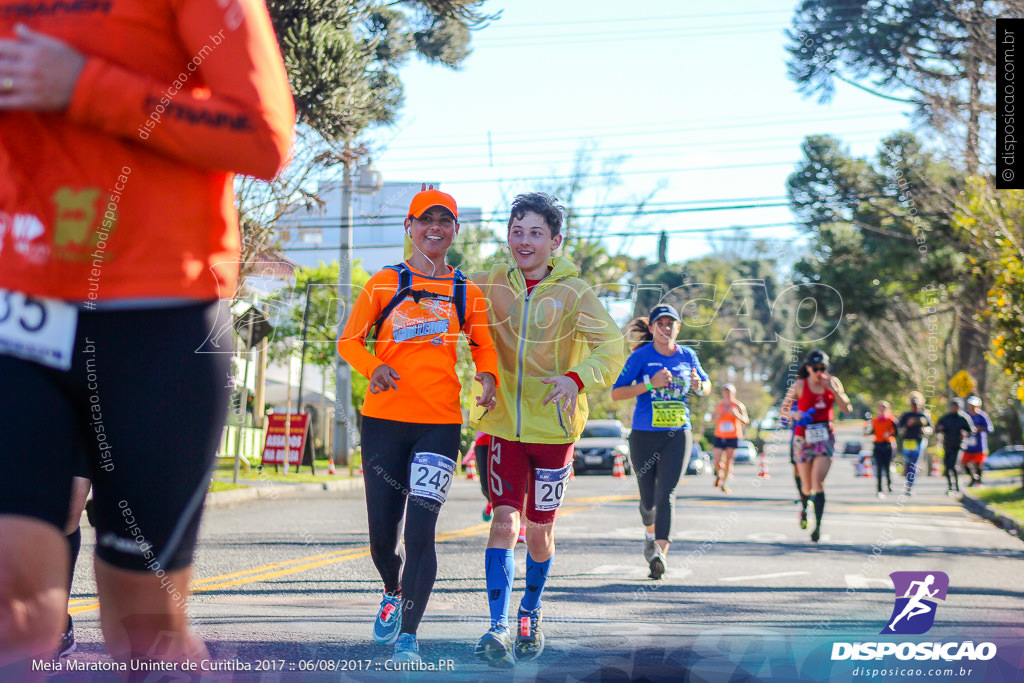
[781, 349, 853, 543]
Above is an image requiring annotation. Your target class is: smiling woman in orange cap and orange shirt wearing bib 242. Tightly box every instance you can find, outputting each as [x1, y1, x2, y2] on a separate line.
[338, 189, 498, 661]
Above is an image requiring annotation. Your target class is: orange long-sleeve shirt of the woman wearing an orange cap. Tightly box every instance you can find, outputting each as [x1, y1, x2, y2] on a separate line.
[338, 267, 498, 424]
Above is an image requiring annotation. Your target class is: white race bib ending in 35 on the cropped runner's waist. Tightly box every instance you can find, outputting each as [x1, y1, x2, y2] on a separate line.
[0, 290, 78, 370]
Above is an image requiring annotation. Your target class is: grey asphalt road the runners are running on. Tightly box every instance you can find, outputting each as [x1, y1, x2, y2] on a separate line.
[59, 423, 1024, 681]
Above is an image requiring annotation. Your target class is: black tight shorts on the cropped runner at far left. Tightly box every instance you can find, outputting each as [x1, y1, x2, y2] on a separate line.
[0, 302, 230, 572]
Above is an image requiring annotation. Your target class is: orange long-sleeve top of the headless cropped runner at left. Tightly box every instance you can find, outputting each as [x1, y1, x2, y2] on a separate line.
[0, 0, 295, 301]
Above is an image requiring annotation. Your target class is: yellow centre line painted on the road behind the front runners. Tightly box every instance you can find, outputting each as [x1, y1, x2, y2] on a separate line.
[68, 496, 618, 615]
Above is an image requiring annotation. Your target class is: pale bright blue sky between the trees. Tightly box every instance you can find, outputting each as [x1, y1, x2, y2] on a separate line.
[364, 0, 908, 260]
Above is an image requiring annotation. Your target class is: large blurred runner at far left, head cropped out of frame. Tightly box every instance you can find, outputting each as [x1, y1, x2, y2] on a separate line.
[0, 0, 295, 680]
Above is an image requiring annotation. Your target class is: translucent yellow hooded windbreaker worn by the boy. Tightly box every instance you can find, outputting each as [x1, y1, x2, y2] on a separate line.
[470, 257, 627, 443]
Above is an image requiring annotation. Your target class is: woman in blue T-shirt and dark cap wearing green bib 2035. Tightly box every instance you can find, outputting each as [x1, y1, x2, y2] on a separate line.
[611, 304, 711, 580]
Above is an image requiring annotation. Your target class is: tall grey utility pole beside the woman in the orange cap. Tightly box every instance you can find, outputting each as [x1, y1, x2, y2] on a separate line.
[334, 158, 382, 465]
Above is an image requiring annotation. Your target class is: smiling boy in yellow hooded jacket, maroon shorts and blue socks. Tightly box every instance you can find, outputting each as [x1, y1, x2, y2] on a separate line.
[471, 193, 626, 668]
